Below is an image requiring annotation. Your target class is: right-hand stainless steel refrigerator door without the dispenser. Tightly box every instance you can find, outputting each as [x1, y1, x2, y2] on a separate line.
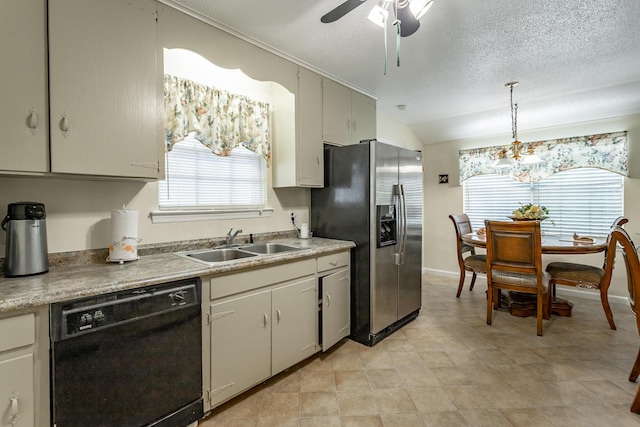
[398, 149, 422, 319]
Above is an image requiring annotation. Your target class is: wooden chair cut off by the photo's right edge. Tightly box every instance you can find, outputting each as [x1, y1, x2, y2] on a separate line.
[611, 226, 640, 414]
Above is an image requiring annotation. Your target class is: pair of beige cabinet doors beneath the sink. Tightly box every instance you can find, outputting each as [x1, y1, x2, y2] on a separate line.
[208, 276, 318, 407]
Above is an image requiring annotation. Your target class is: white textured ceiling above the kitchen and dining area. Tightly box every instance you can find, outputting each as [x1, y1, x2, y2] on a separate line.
[163, 0, 640, 143]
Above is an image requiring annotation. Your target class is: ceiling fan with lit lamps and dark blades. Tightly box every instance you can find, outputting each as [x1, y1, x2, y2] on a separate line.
[320, 0, 433, 37]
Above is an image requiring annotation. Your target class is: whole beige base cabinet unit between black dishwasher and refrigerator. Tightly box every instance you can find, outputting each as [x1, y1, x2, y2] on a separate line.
[202, 251, 350, 412]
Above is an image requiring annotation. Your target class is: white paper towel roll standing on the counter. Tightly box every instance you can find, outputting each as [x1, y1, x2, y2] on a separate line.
[107, 209, 140, 262]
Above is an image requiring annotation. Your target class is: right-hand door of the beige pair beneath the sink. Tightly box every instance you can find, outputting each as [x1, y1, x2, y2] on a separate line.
[271, 276, 318, 375]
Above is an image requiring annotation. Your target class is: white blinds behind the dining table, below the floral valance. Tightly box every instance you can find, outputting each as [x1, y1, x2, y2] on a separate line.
[463, 168, 624, 235]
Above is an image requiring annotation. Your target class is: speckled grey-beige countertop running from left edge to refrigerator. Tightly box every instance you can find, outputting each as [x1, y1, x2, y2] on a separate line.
[0, 237, 355, 313]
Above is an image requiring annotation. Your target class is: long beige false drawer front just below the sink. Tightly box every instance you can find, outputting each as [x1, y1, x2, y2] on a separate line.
[210, 259, 316, 300]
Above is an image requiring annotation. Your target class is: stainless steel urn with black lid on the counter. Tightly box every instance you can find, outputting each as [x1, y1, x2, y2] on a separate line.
[2, 202, 49, 277]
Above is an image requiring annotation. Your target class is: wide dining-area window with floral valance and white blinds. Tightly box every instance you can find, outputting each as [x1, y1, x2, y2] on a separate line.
[459, 131, 629, 236]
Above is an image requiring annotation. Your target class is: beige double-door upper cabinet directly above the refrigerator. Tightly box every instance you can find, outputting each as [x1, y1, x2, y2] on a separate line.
[322, 79, 376, 145]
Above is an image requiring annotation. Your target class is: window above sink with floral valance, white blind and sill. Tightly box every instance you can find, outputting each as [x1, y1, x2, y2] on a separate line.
[151, 67, 273, 223]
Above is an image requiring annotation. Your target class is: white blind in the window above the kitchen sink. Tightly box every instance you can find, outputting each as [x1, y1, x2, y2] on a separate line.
[158, 134, 267, 210]
